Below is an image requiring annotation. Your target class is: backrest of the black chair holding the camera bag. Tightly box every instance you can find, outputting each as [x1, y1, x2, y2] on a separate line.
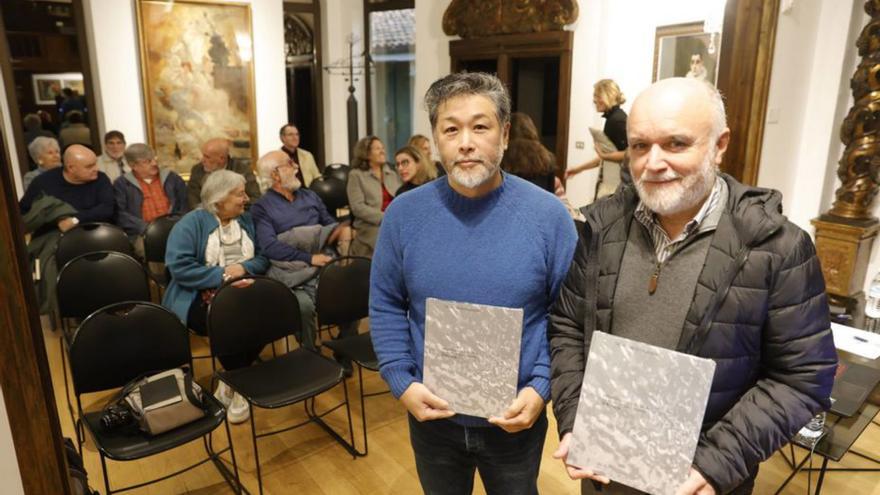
[70, 301, 192, 395]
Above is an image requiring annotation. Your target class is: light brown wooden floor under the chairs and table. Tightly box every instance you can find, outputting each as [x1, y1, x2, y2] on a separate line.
[44, 331, 880, 495]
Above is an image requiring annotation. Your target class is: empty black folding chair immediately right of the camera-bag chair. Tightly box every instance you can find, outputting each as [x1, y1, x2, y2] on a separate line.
[208, 276, 356, 494]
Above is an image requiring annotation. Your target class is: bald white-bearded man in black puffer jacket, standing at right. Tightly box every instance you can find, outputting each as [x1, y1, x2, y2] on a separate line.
[548, 78, 837, 495]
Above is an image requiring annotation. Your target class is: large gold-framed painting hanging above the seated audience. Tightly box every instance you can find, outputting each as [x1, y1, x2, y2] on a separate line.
[136, 0, 257, 179]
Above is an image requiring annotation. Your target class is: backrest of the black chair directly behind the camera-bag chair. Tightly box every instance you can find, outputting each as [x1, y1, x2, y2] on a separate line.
[56, 251, 150, 318]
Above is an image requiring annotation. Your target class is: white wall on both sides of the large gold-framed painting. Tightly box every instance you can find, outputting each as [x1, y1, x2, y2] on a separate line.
[84, 0, 287, 165]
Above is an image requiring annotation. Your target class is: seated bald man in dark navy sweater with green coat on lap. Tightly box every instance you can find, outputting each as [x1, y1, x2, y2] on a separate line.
[19, 140, 114, 313]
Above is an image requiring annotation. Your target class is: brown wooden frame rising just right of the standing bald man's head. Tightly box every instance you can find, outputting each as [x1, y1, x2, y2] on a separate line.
[718, 0, 779, 185]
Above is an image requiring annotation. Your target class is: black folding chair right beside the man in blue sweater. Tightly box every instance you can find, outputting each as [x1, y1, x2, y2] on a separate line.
[315, 256, 388, 456]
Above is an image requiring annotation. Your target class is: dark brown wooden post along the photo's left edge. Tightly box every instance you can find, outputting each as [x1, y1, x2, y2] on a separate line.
[0, 9, 71, 495]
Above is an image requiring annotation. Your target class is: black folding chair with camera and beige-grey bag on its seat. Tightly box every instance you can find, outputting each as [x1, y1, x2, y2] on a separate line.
[70, 302, 241, 495]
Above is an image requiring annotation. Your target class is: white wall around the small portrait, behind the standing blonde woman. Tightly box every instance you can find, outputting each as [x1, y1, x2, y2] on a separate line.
[568, 0, 724, 206]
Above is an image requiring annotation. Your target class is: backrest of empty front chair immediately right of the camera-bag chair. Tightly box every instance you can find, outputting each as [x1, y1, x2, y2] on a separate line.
[207, 275, 302, 356]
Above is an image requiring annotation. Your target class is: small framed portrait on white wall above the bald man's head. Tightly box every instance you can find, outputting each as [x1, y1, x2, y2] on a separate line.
[652, 22, 721, 86]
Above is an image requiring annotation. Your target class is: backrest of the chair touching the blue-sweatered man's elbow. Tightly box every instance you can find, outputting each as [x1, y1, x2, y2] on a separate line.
[315, 256, 370, 325]
